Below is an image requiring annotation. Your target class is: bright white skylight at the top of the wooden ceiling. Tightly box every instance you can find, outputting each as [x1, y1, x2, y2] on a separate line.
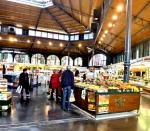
[7, 0, 53, 8]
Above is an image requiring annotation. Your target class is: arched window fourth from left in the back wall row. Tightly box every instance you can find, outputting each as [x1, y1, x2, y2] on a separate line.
[47, 55, 60, 65]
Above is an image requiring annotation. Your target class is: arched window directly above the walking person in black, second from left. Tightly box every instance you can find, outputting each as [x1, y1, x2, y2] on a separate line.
[14, 54, 30, 63]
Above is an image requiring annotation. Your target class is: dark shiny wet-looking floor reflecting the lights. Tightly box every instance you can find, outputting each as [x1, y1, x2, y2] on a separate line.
[0, 87, 150, 131]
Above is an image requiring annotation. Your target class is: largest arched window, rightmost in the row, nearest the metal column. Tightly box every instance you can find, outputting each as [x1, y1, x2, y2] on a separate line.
[89, 54, 106, 66]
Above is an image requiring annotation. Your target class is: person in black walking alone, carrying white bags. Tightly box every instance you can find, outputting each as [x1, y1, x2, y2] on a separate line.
[19, 68, 30, 98]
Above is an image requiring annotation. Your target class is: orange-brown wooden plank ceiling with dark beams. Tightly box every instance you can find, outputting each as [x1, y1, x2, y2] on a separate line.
[0, 0, 150, 54]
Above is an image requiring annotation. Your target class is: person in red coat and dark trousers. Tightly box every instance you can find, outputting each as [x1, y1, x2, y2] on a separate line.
[50, 69, 62, 102]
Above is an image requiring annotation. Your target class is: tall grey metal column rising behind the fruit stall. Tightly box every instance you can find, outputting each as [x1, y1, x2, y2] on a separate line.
[124, 0, 132, 82]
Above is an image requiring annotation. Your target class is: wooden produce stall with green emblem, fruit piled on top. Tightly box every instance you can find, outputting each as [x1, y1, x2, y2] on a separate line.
[74, 81, 140, 115]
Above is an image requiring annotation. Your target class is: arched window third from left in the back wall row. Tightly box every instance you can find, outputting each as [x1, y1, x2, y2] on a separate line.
[31, 54, 45, 64]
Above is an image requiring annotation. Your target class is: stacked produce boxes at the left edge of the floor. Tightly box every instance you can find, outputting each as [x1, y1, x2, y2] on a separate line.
[0, 79, 12, 111]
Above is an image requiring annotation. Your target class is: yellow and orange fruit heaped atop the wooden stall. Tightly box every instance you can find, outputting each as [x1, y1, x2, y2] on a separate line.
[75, 80, 140, 93]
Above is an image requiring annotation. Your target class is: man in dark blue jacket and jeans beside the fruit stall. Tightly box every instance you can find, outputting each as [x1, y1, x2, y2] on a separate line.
[61, 66, 74, 110]
